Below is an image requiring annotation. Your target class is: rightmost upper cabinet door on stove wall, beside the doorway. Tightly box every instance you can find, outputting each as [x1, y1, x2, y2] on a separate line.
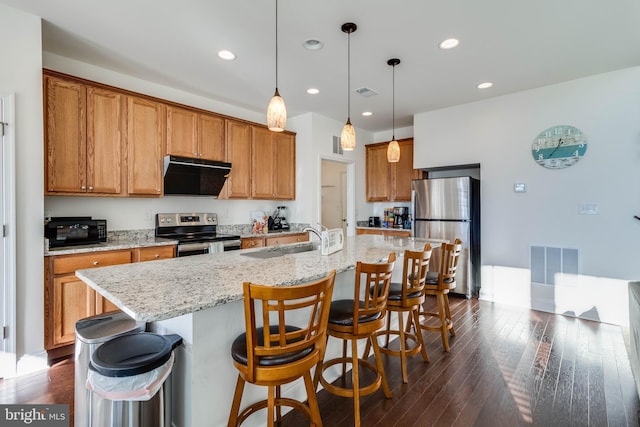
[271, 133, 296, 200]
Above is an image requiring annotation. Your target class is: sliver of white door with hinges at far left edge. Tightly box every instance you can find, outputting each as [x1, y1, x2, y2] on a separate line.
[0, 95, 16, 378]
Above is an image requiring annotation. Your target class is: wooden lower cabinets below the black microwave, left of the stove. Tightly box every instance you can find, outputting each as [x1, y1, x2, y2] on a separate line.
[44, 245, 176, 355]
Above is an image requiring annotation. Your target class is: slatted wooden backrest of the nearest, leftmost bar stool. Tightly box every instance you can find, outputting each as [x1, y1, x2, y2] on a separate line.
[243, 270, 336, 378]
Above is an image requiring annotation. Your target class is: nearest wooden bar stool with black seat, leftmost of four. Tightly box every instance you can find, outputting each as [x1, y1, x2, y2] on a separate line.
[227, 270, 336, 427]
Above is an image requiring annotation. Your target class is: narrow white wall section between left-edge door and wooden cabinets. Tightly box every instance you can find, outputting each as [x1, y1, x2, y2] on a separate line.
[0, 5, 44, 357]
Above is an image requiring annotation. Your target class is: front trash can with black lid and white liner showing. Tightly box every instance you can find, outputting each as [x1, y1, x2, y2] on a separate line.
[88, 332, 182, 427]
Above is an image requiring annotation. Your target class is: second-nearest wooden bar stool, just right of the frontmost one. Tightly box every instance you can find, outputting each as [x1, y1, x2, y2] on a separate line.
[315, 252, 396, 426]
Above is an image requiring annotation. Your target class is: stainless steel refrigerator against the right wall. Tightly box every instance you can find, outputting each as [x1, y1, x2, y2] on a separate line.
[411, 176, 480, 298]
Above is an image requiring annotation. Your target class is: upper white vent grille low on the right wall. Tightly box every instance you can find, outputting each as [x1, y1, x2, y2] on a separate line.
[530, 246, 579, 286]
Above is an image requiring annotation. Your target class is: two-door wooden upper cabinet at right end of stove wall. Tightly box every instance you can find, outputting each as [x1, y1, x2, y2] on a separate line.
[251, 126, 296, 200]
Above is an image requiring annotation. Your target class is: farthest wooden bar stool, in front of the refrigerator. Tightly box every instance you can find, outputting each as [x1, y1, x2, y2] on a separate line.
[407, 239, 462, 352]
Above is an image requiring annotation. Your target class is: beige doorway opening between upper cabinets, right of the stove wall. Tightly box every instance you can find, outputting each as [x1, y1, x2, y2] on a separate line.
[320, 159, 349, 236]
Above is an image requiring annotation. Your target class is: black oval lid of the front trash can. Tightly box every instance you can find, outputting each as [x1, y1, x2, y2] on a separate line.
[89, 332, 182, 377]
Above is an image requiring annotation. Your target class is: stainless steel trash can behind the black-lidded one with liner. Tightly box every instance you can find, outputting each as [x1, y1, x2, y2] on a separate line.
[74, 312, 145, 427]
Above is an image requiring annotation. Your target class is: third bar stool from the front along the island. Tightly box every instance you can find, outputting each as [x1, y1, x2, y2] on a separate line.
[365, 243, 431, 383]
